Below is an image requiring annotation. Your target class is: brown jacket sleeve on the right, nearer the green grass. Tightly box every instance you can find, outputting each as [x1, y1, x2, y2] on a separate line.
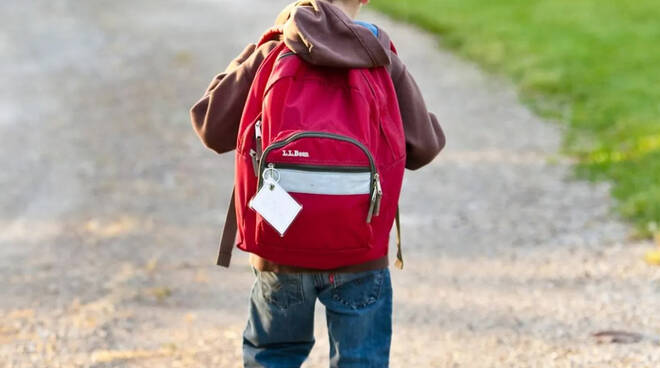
[391, 54, 445, 170]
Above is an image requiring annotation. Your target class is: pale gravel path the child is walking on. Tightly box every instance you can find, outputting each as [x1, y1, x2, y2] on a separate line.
[0, 0, 660, 368]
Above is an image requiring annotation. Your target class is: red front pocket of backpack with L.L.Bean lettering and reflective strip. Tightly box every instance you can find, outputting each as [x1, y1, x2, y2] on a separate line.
[256, 132, 382, 253]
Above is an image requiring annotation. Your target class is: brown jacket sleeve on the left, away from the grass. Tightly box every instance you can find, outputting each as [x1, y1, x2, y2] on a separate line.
[190, 41, 277, 153]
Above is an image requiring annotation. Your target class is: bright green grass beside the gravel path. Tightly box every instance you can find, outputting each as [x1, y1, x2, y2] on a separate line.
[372, 0, 660, 235]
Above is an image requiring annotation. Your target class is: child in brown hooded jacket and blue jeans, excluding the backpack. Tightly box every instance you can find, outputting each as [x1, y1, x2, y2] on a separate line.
[191, 0, 445, 367]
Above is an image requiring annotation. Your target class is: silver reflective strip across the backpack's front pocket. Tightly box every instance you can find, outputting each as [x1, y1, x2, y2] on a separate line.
[277, 169, 371, 195]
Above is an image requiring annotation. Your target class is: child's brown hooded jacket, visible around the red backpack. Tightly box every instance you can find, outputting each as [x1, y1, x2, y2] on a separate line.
[190, 0, 445, 272]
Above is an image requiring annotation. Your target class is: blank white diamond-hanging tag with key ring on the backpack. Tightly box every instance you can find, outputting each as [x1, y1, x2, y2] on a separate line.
[249, 167, 302, 236]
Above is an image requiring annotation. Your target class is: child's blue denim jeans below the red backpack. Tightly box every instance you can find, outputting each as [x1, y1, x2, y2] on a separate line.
[243, 268, 392, 368]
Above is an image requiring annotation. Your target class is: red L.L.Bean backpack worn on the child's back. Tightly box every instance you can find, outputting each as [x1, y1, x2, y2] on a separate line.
[218, 29, 406, 269]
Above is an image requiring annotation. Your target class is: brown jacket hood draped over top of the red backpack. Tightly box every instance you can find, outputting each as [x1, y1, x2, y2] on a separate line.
[276, 0, 391, 68]
